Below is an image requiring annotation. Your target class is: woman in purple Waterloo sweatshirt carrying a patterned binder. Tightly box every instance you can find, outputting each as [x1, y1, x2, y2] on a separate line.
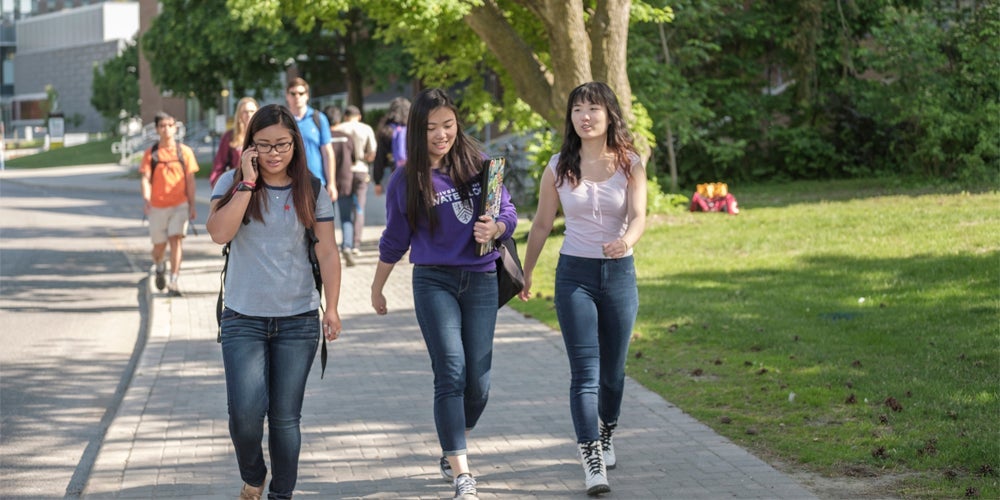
[371, 89, 517, 498]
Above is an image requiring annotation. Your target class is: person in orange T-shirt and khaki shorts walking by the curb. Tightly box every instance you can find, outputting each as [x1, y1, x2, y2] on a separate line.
[139, 111, 198, 295]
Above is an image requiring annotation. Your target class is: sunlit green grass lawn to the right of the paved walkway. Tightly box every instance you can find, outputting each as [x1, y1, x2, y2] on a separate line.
[512, 180, 1000, 498]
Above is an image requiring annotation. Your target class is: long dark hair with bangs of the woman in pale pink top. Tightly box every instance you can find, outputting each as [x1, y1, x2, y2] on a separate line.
[556, 82, 635, 186]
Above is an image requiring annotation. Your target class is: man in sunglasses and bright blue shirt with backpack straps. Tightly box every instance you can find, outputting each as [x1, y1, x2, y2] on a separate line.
[285, 77, 340, 202]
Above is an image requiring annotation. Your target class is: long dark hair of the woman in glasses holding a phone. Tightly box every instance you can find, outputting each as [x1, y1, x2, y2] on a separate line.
[218, 104, 317, 227]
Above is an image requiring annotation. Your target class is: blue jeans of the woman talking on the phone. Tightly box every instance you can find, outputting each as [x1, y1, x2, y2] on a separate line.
[222, 308, 319, 499]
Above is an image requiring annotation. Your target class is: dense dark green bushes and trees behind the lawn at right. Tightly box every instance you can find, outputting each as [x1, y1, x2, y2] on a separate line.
[629, 0, 1000, 191]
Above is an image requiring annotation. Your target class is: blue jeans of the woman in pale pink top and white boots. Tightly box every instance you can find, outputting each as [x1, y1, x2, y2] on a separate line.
[555, 255, 639, 443]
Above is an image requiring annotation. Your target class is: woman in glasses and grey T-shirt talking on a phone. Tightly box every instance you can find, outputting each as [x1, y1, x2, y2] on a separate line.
[205, 105, 340, 499]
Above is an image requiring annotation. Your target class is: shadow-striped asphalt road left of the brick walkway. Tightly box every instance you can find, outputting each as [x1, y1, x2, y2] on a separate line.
[0, 182, 205, 499]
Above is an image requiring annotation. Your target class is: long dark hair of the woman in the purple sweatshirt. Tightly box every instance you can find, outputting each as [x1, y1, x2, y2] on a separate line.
[405, 89, 482, 232]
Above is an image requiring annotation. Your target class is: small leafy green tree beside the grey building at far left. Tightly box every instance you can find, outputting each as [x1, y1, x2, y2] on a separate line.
[90, 41, 139, 133]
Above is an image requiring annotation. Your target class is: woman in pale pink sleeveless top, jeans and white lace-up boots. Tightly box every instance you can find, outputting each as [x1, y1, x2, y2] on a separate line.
[520, 82, 646, 495]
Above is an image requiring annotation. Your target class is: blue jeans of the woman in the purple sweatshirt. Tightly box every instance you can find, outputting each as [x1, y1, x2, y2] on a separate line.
[413, 266, 497, 456]
